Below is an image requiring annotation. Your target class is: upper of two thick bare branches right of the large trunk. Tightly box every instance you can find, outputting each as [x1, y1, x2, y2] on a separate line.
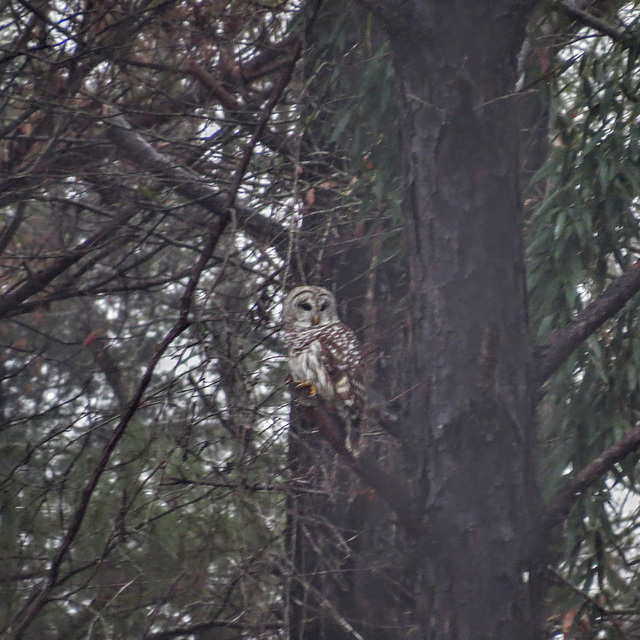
[536, 260, 640, 384]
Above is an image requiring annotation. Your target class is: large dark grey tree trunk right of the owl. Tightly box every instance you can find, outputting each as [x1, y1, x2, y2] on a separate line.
[374, 0, 539, 640]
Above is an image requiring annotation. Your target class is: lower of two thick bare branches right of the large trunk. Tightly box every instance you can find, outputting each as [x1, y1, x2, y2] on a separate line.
[543, 425, 640, 532]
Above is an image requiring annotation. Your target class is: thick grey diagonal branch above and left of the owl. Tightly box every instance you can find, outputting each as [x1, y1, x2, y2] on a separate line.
[106, 116, 287, 254]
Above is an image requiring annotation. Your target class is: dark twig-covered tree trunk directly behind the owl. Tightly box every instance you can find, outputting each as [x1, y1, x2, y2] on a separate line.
[287, 0, 408, 640]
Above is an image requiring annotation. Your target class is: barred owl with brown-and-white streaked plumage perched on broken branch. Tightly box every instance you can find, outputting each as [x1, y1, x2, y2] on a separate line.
[282, 287, 364, 448]
